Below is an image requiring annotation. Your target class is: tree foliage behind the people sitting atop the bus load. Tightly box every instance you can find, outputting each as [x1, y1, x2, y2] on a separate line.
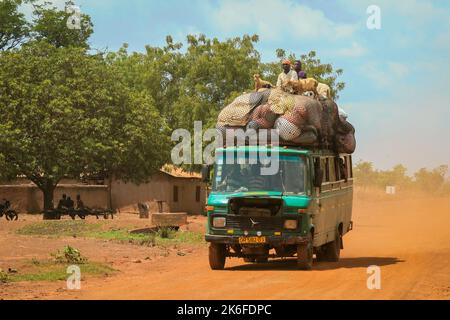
[261, 49, 345, 100]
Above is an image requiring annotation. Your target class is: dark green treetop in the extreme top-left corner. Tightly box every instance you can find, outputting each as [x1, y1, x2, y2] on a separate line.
[0, 0, 30, 51]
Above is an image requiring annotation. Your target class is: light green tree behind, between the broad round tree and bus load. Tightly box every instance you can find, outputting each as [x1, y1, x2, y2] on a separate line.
[108, 35, 260, 129]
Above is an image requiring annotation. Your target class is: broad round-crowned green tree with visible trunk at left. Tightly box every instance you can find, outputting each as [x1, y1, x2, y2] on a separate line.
[0, 41, 170, 210]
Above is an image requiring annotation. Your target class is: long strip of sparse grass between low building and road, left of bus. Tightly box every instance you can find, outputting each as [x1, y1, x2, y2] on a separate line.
[17, 220, 204, 246]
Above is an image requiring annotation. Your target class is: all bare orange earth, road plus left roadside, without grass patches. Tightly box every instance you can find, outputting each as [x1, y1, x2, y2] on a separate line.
[0, 194, 450, 299]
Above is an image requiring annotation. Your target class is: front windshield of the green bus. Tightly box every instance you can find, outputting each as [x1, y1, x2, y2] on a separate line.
[213, 155, 306, 194]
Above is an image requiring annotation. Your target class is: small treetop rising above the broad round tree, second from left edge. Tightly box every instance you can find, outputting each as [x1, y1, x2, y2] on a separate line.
[32, 1, 93, 48]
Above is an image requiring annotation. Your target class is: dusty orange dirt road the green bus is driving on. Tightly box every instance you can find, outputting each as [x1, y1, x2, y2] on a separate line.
[1, 192, 450, 299]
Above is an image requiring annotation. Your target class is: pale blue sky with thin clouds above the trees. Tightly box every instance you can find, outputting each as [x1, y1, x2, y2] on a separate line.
[23, 0, 450, 173]
